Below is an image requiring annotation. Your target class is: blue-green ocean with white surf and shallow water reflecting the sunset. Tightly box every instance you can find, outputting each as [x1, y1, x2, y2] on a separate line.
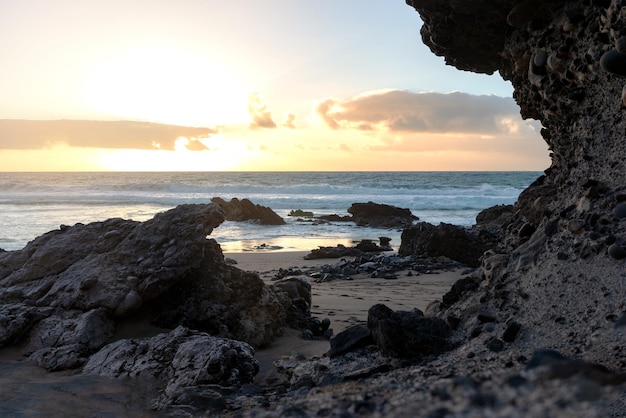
[0, 172, 542, 253]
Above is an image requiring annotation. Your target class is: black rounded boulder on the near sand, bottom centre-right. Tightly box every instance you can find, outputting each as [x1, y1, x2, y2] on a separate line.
[367, 304, 451, 358]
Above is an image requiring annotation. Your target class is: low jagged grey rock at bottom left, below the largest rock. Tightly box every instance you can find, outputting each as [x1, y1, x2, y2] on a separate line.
[83, 327, 259, 409]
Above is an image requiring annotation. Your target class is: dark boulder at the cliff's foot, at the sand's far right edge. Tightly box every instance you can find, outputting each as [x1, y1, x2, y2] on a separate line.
[398, 222, 496, 267]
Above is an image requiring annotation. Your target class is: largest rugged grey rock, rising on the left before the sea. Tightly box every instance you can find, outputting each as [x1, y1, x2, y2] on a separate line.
[0, 204, 300, 370]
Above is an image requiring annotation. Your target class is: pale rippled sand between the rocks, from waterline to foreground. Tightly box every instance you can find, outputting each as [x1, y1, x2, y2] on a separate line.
[224, 251, 462, 384]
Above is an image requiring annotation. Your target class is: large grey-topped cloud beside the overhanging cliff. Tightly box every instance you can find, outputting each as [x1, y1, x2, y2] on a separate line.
[316, 90, 538, 135]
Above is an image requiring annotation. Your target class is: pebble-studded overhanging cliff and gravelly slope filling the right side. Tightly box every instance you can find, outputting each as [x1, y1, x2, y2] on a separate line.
[230, 0, 626, 417]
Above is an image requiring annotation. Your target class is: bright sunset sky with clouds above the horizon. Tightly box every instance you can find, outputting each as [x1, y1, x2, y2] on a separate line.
[0, 0, 549, 171]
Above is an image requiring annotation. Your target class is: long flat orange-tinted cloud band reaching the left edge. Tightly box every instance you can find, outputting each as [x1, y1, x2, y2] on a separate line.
[0, 119, 217, 150]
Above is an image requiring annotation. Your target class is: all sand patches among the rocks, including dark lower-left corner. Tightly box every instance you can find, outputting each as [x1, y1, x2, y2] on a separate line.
[0, 251, 461, 416]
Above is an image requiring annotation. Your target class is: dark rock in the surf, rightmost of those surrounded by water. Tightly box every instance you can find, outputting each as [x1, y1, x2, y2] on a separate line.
[348, 202, 418, 228]
